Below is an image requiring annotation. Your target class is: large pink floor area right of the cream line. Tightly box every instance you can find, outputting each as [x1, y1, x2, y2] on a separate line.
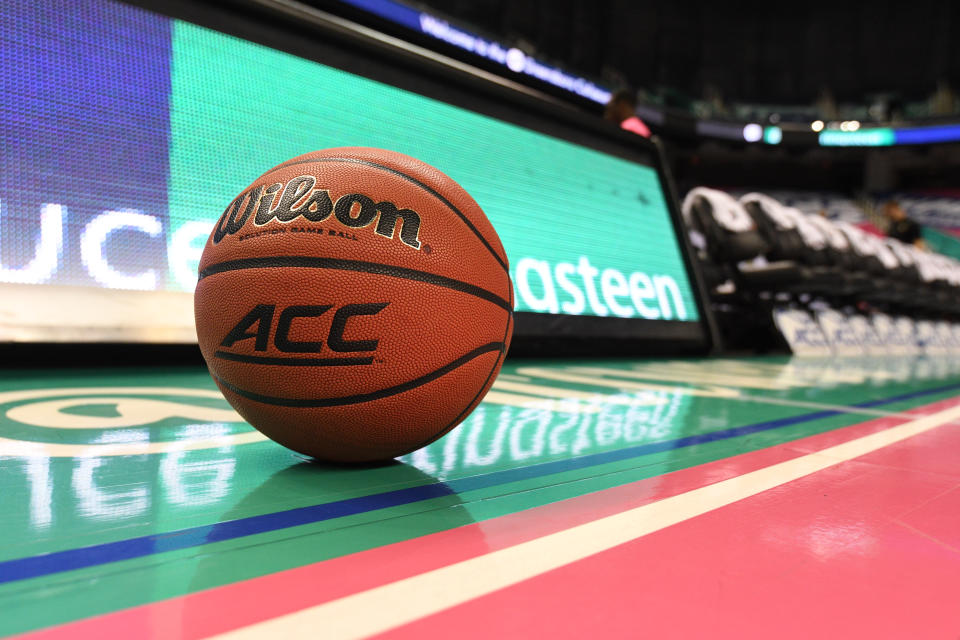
[384, 401, 960, 640]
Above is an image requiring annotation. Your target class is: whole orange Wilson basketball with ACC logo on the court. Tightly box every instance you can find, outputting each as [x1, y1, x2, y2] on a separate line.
[194, 147, 513, 461]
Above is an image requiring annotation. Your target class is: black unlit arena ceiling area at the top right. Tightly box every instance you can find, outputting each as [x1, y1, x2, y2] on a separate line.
[419, 0, 960, 106]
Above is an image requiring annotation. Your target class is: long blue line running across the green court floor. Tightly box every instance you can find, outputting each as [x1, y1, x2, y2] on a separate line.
[0, 384, 960, 584]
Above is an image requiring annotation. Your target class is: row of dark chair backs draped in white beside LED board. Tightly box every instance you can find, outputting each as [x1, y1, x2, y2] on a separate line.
[682, 187, 960, 316]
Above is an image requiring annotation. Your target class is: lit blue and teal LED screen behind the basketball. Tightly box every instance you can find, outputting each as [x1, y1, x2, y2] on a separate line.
[0, 0, 700, 348]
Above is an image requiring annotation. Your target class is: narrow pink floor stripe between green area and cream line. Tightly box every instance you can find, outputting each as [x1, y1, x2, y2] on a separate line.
[18, 400, 960, 640]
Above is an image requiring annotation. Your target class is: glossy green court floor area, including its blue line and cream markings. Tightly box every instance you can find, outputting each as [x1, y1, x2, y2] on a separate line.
[0, 358, 960, 636]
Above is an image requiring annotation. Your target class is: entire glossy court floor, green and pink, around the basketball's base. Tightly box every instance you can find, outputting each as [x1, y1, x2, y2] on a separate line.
[0, 358, 960, 639]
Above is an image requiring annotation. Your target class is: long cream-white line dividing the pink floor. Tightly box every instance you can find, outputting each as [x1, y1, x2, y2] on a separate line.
[217, 406, 960, 640]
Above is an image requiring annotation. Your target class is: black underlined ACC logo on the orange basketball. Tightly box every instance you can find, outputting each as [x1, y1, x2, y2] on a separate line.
[214, 302, 390, 366]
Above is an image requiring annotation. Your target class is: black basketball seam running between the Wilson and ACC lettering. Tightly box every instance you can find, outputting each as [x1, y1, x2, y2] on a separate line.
[199, 256, 513, 311]
